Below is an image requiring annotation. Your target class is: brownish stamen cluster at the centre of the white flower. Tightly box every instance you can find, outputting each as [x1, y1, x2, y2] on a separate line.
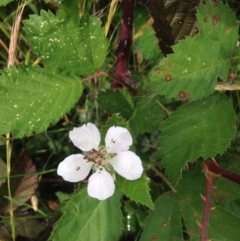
[84, 147, 107, 167]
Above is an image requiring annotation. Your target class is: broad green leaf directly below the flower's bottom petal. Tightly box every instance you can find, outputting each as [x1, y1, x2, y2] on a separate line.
[50, 189, 123, 241]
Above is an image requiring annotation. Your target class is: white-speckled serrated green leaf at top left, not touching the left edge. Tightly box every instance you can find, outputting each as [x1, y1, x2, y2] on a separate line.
[24, 11, 108, 75]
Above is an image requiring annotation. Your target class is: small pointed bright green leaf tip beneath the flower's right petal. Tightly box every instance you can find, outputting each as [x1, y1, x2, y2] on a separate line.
[116, 174, 154, 209]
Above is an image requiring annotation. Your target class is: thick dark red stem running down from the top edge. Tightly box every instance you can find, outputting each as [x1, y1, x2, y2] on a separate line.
[112, 0, 135, 90]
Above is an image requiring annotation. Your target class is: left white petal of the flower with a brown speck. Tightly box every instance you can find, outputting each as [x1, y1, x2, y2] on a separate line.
[57, 154, 93, 182]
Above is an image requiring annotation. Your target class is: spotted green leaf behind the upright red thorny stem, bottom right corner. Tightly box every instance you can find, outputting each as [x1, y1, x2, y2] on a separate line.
[176, 171, 240, 241]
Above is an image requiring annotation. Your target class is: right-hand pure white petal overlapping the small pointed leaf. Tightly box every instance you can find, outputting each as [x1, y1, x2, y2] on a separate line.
[108, 151, 143, 180]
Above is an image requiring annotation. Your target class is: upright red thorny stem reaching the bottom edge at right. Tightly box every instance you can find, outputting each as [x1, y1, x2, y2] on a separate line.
[199, 163, 214, 241]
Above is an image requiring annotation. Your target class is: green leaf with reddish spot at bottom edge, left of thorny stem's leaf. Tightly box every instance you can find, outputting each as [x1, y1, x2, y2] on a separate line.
[140, 192, 184, 241]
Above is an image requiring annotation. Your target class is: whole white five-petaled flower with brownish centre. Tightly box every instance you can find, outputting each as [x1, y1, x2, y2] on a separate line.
[57, 123, 143, 200]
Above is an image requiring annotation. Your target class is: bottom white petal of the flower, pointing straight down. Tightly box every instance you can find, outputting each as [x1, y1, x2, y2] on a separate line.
[87, 169, 115, 200]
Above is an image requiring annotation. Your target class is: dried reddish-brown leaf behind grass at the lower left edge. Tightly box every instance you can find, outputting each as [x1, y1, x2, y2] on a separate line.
[0, 151, 38, 213]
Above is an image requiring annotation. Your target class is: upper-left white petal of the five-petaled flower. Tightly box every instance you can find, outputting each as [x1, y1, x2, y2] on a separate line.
[69, 123, 101, 151]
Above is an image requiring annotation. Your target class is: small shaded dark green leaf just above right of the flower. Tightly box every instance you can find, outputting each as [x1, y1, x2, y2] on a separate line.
[130, 96, 165, 134]
